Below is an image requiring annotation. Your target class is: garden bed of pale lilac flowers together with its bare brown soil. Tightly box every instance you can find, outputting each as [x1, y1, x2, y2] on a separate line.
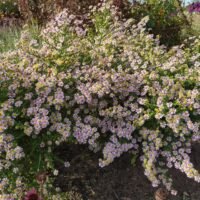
[0, 0, 200, 200]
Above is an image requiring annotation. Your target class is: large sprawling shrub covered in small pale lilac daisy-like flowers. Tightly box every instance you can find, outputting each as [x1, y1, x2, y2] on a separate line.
[0, 2, 200, 199]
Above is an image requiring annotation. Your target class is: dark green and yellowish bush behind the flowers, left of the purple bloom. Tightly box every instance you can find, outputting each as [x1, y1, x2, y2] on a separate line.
[132, 0, 189, 47]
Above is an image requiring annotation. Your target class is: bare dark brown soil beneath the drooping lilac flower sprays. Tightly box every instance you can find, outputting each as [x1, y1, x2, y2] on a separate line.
[55, 145, 200, 200]
